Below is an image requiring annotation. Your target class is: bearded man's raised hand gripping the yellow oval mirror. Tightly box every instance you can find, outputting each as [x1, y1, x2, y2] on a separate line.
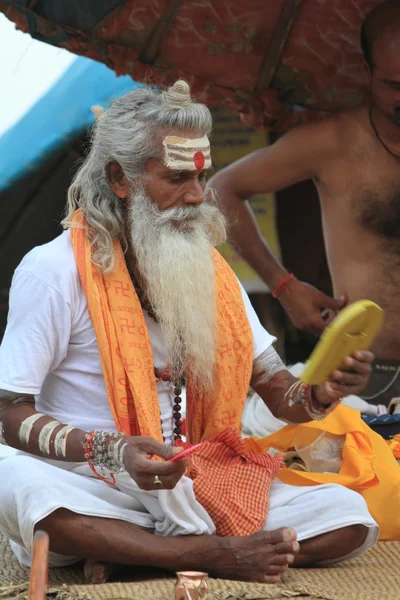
[313, 350, 375, 404]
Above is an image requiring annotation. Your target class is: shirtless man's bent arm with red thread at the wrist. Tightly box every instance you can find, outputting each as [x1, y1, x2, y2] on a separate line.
[208, 119, 343, 334]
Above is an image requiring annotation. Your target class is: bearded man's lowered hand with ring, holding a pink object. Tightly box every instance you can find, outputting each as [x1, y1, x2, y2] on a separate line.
[124, 437, 187, 490]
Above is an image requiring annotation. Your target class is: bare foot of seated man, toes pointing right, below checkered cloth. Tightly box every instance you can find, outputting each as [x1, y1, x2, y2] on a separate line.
[208, 527, 300, 583]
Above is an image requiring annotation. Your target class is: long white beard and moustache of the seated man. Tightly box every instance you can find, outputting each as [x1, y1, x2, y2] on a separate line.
[128, 185, 226, 390]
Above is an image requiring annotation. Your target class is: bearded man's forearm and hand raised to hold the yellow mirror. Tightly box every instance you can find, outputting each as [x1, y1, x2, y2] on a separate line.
[250, 347, 374, 423]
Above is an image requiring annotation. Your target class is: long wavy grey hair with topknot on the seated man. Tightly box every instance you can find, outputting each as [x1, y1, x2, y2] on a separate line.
[62, 81, 212, 273]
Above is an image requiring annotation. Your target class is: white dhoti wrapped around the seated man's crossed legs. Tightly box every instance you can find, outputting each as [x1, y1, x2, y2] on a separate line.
[0, 453, 379, 567]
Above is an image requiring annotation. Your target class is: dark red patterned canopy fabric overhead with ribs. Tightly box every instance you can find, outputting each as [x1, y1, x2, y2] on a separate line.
[0, 0, 383, 131]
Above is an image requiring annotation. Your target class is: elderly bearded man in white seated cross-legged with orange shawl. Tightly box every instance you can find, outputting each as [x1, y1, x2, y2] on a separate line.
[0, 81, 378, 582]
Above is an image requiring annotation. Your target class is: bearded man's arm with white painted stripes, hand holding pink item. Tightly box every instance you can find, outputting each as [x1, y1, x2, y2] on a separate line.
[0, 391, 186, 490]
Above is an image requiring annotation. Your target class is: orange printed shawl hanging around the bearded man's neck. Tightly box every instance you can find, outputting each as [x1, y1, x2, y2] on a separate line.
[71, 210, 253, 444]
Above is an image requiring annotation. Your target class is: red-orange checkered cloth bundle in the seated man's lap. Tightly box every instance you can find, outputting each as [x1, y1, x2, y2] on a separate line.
[186, 428, 282, 536]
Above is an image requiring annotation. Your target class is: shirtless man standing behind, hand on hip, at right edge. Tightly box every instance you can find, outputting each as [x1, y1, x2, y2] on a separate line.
[210, 0, 400, 404]
